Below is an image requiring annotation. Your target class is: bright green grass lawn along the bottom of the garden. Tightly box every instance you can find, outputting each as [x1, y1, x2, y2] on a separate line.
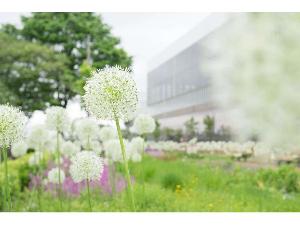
[2, 155, 300, 212]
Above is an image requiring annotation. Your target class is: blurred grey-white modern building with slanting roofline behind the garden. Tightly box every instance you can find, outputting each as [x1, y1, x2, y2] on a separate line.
[147, 13, 228, 128]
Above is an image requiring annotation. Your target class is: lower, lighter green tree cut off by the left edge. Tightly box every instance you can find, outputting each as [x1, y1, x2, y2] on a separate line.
[0, 32, 72, 112]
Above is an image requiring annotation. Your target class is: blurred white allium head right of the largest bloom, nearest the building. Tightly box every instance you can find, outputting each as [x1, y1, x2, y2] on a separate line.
[132, 115, 155, 134]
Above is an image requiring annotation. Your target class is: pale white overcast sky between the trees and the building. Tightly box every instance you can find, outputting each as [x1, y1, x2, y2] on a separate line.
[0, 13, 208, 125]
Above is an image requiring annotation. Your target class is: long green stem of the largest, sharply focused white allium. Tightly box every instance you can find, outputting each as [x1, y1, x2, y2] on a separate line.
[115, 116, 136, 211]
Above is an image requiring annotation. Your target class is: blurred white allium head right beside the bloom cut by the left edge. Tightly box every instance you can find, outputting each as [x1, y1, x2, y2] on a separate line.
[27, 125, 51, 151]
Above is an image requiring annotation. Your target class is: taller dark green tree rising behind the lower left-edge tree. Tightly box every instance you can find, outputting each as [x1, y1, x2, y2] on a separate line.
[18, 12, 132, 94]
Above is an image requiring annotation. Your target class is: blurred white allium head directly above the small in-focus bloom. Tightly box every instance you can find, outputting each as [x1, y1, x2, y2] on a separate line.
[75, 118, 99, 141]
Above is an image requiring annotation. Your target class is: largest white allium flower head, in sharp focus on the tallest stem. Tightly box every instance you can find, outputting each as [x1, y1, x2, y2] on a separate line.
[83, 66, 138, 121]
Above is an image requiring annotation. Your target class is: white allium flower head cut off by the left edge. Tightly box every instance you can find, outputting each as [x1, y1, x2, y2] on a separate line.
[0, 105, 27, 147]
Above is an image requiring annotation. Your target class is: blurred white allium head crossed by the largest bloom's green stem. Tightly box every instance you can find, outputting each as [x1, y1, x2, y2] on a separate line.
[103, 139, 131, 162]
